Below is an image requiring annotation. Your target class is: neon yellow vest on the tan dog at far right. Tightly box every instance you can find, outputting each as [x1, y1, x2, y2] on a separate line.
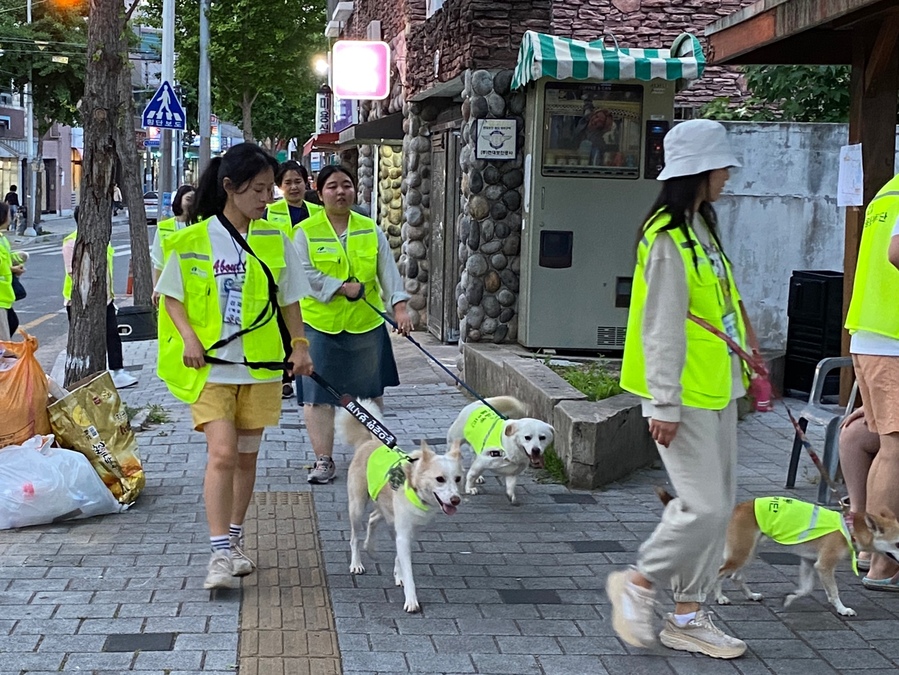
[754, 497, 858, 574]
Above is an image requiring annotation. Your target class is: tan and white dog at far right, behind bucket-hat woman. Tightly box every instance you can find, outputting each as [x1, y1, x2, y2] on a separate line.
[657, 488, 899, 616]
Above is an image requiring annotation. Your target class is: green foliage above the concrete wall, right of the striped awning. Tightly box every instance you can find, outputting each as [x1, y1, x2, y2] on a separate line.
[701, 66, 850, 122]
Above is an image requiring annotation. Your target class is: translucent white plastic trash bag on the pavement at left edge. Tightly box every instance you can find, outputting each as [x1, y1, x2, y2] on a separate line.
[0, 436, 128, 530]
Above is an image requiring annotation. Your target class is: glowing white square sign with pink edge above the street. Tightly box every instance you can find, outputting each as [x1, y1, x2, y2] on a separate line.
[331, 40, 390, 101]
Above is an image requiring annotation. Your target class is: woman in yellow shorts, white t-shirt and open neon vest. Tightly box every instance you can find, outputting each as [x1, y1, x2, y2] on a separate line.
[156, 143, 312, 588]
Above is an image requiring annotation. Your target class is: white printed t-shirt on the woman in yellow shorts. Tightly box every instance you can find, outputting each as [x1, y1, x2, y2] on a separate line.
[156, 218, 311, 384]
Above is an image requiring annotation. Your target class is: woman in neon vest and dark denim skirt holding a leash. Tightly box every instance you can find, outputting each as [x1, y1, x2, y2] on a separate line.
[294, 166, 412, 483]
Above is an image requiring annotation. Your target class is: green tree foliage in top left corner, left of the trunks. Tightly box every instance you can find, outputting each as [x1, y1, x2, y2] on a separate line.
[0, 0, 88, 136]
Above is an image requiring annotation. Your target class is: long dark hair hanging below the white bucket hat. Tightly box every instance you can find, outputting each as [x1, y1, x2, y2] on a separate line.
[637, 171, 727, 269]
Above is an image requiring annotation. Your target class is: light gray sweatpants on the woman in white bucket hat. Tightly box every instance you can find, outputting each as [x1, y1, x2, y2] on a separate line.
[637, 401, 737, 603]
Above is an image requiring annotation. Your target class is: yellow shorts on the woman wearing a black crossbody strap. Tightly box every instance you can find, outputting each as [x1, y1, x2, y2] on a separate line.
[190, 381, 281, 431]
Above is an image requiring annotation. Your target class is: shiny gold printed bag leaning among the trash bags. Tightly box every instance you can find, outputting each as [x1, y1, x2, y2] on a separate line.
[49, 370, 146, 504]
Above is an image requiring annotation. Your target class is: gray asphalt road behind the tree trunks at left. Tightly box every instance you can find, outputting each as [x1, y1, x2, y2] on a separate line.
[13, 221, 148, 372]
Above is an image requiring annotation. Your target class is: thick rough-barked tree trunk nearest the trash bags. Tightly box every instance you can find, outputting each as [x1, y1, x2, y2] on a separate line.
[65, 0, 128, 385]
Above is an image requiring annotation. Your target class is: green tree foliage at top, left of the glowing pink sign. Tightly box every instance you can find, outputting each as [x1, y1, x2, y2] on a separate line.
[144, 0, 328, 140]
